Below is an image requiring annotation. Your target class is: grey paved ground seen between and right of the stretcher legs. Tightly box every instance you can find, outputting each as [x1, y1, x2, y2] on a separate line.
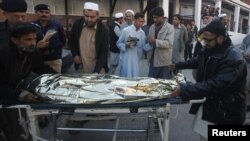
[41, 104, 199, 141]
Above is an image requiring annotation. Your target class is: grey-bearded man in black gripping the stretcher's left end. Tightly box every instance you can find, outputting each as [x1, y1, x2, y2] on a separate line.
[0, 23, 54, 141]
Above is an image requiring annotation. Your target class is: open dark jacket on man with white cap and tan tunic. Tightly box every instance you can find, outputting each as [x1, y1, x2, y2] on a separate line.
[68, 18, 109, 73]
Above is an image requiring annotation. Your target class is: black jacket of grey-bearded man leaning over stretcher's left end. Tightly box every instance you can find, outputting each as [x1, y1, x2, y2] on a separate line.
[0, 44, 54, 102]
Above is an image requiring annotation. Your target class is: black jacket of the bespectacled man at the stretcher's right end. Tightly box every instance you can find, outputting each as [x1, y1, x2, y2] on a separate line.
[176, 38, 247, 124]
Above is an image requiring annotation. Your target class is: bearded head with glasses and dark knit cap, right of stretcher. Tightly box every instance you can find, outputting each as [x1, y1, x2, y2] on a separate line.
[202, 19, 227, 48]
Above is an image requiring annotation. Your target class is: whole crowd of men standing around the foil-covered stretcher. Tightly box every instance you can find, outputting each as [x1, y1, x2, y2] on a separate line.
[0, 0, 250, 141]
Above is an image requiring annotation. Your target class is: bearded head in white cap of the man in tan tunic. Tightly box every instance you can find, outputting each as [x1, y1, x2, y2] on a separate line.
[83, 2, 99, 28]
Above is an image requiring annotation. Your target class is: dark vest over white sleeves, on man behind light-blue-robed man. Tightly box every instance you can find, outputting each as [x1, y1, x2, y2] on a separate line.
[109, 22, 120, 53]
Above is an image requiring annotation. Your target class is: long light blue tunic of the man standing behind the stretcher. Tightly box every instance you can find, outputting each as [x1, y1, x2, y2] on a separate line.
[116, 25, 146, 78]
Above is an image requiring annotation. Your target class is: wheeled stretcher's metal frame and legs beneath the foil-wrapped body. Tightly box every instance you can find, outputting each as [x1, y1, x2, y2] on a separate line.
[1, 98, 205, 141]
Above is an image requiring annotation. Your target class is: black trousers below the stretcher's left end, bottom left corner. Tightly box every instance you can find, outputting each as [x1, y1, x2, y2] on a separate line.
[0, 109, 31, 141]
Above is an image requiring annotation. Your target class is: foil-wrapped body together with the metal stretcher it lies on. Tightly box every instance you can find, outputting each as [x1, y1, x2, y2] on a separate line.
[0, 74, 204, 141]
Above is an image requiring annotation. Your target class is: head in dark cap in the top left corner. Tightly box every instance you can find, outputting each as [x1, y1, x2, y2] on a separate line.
[0, 0, 27, 26]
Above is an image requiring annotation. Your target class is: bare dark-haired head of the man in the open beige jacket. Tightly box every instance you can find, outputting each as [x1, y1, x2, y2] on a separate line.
[151, 7, 165, 26]
